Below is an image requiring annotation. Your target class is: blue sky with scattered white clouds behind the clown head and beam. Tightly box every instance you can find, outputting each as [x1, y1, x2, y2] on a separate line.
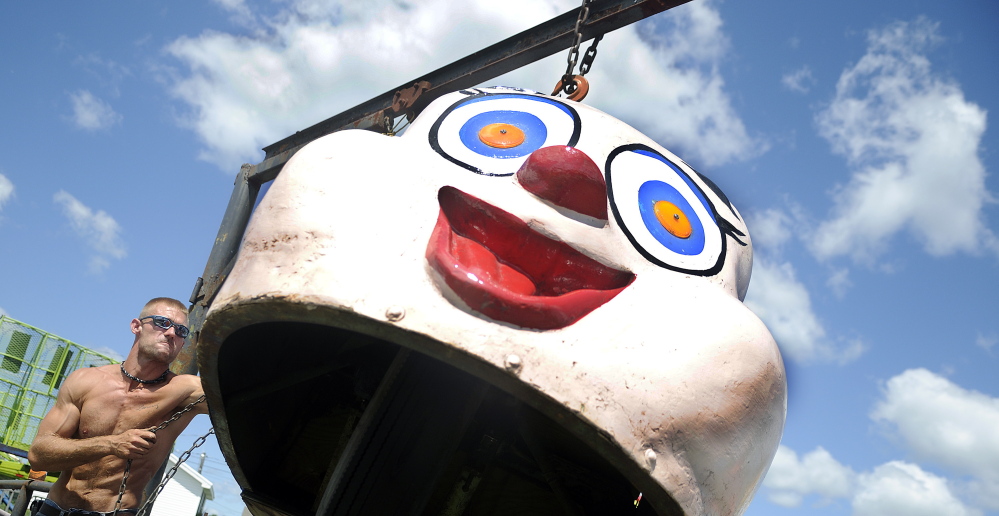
[0, 0, 999, 515]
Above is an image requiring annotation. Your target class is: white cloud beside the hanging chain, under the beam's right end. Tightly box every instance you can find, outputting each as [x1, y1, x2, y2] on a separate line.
[584, 2, 768, 167]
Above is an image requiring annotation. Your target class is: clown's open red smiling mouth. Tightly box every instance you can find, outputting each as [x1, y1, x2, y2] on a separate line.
[426, 186, 635, 330]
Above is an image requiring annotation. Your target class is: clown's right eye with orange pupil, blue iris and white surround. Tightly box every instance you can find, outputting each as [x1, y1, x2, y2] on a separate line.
[607, 144, 725, 275]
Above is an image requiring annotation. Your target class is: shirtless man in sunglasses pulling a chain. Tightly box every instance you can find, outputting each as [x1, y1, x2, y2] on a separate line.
[28, 298, 208, 516]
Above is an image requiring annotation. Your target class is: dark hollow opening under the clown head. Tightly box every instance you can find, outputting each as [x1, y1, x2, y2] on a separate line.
[217, 322, 682, 516]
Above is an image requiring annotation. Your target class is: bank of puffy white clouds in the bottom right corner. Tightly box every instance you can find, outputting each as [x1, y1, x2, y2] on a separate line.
[763, 369, 999, 516]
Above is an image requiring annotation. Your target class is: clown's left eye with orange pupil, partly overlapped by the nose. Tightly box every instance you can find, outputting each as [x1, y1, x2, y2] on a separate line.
[430, 93, 580, 176]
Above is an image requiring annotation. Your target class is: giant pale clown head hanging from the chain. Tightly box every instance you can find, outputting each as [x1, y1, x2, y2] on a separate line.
[199, 88, 786, 515]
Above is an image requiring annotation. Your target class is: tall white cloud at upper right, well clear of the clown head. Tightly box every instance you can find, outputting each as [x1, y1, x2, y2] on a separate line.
[811, 18, 999, 263]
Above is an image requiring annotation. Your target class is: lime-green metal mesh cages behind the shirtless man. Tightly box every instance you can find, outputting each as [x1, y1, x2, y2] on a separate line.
[0, 315, 116, 456]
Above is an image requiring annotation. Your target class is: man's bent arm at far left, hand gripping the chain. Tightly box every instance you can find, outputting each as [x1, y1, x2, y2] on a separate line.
[28, 369, 156, 471]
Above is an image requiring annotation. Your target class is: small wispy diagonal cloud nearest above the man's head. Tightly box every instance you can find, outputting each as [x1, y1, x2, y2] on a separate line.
[52, 190, 126, 273]
